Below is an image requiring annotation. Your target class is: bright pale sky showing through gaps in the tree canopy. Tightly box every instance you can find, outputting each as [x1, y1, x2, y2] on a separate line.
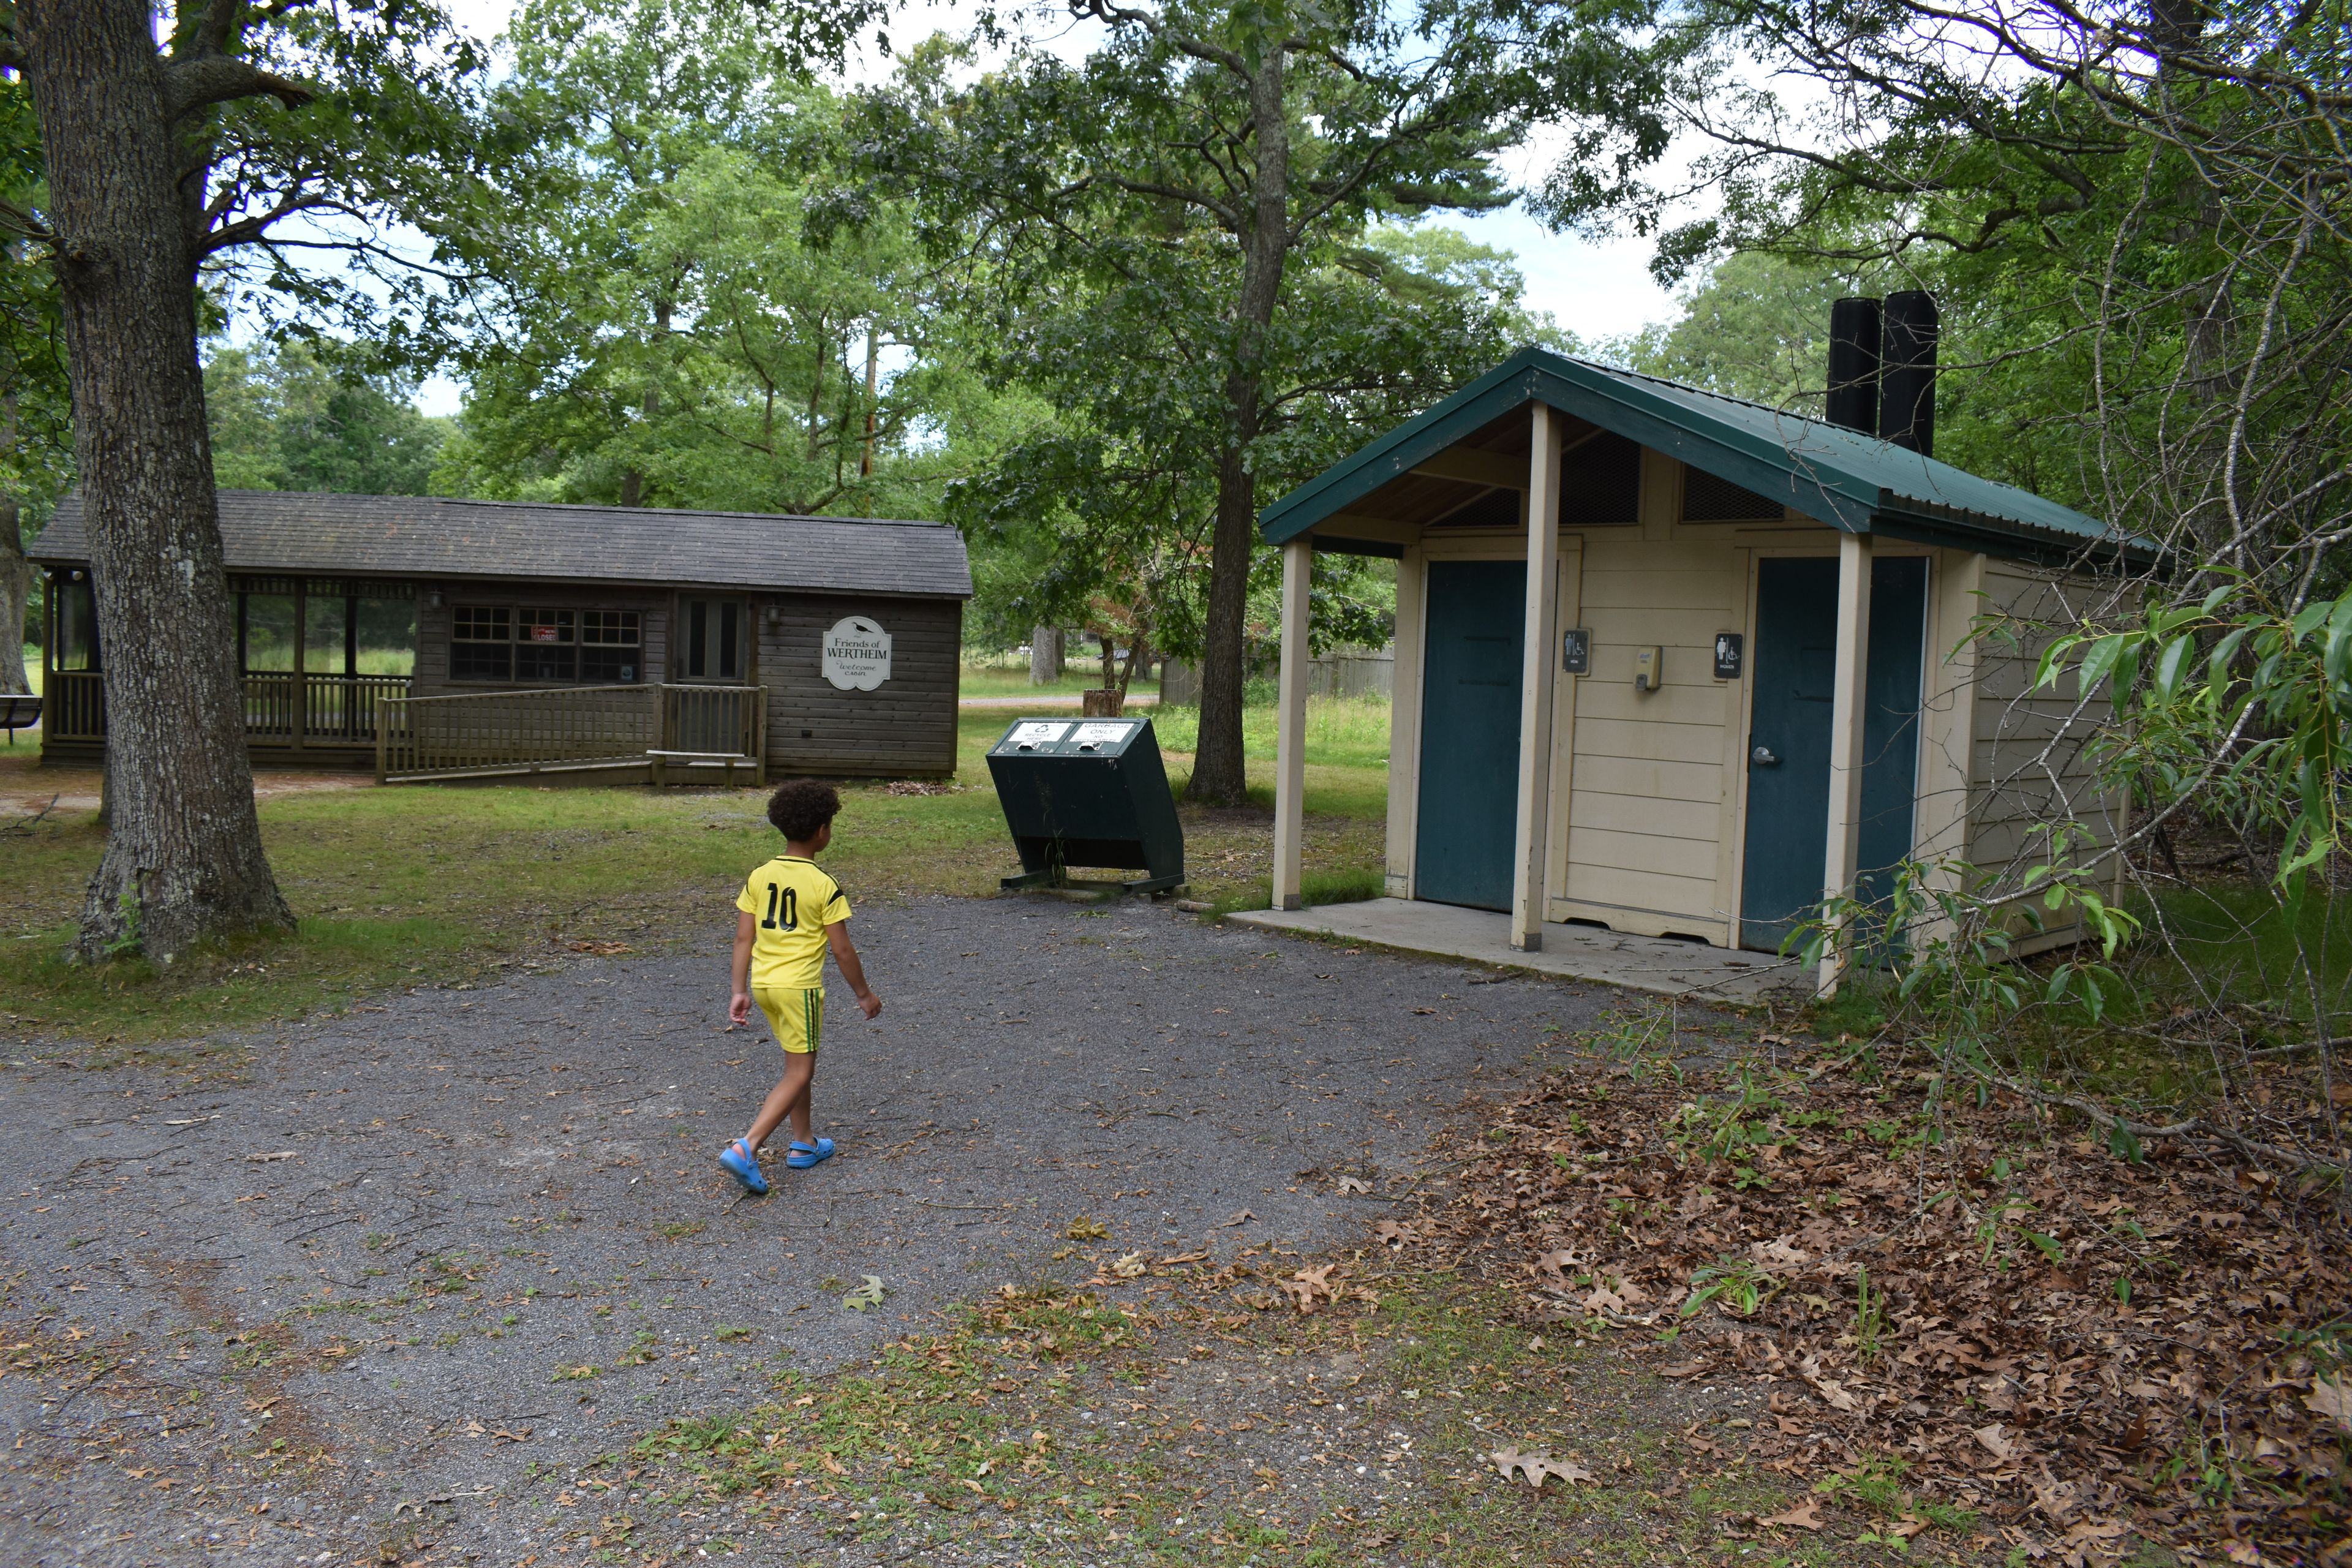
[417, 0, 1679, 414]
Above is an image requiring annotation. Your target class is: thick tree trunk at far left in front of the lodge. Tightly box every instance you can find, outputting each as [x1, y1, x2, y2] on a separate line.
[17, 0, 294, 962]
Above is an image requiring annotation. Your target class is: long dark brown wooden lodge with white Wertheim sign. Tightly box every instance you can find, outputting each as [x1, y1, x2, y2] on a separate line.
[31, 489, 971, 783]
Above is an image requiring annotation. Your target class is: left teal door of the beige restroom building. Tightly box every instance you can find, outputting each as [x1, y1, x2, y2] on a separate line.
[1414, 562, 1526, 910]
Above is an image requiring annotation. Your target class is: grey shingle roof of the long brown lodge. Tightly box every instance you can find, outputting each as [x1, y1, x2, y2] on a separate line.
[31, 489, 971, 600]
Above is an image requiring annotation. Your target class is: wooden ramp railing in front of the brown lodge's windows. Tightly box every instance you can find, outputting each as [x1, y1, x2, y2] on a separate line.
[376, 687, 767, 783]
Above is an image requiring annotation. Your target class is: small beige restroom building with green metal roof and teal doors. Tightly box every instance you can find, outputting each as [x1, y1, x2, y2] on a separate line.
[1261, 338, 2147, 980]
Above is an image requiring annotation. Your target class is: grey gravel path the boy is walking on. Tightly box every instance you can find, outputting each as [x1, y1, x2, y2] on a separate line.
[0, 900, 1611, 1568]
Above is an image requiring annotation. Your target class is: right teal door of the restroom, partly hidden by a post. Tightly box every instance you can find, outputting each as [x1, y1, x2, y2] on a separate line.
[1741, 557, 1926, 952]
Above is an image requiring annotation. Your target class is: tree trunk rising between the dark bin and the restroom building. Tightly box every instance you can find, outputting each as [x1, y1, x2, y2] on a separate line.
[1185, 42, 1291, 806]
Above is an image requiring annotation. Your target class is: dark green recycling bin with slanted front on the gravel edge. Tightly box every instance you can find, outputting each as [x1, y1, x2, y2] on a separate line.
[988, 719, 1183, 893]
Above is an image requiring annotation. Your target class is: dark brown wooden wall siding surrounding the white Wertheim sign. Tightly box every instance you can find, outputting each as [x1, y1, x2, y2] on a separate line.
[753, 595, 964, 778]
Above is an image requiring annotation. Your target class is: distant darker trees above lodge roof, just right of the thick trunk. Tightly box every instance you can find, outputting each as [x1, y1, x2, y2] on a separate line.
[205, 339, 449, 496]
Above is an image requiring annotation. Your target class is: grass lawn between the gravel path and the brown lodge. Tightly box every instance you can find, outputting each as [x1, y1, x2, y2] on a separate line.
[0, 710, 1388, 1049]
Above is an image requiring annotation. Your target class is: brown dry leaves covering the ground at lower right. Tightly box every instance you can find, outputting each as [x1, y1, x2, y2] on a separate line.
[1411, 1034, 2352, 1563]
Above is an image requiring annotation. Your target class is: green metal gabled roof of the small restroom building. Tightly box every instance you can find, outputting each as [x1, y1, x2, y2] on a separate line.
[1258, 348, 2154, 562]
